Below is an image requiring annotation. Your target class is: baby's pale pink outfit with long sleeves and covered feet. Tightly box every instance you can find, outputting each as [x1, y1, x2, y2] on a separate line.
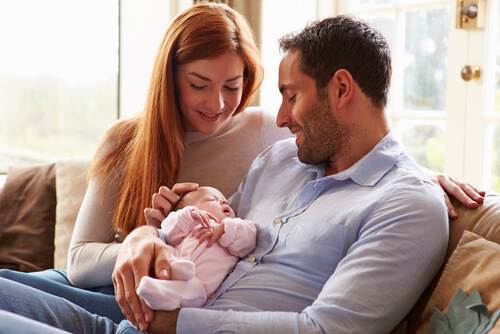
[137, 206, 257, 311]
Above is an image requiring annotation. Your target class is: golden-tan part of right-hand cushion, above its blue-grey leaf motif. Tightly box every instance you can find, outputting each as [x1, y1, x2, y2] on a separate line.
[417, 231, 500, 333]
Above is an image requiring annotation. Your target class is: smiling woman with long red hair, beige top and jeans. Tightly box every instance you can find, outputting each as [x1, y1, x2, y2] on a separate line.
[0, 4, 484, 332]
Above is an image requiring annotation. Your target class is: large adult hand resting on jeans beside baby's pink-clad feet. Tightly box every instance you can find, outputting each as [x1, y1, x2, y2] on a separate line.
[112, 226, 174, 331]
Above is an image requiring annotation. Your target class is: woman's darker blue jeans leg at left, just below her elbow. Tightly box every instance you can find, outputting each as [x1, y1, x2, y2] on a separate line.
[0, 269, 125, 323]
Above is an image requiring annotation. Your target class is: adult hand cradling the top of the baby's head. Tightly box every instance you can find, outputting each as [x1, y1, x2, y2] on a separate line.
[144, 183, 198, 228]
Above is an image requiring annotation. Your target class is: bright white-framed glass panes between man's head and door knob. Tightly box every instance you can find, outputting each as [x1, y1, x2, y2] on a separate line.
[341, 0, 450, 171]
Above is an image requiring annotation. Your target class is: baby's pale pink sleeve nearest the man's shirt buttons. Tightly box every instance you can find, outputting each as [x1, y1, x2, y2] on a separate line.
[219, 218, 257, 257]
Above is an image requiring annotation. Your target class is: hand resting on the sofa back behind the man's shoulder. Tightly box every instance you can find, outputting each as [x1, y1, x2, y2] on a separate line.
[422, 168, 486, 218]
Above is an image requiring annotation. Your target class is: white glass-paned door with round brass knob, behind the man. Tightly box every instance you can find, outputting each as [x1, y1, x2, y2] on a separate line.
[337, 0, 500, 191]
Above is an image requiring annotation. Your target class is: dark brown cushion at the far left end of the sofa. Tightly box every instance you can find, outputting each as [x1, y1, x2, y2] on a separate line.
[0, 163, 56, 272]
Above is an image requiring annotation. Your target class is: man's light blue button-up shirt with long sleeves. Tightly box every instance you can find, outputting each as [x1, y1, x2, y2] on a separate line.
[177, 133, 448, 333]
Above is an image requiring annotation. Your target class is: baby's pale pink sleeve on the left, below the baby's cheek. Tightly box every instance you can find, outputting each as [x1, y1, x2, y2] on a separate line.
[161, 206, 198, 246]
